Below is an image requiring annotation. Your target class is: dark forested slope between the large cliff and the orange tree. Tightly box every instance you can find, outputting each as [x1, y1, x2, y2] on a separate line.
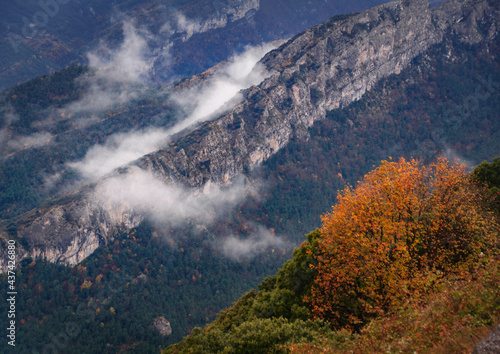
[237, 34, 500, 237]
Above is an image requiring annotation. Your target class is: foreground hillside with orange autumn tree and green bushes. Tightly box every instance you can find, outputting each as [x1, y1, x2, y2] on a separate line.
[164, 158, 500, 353]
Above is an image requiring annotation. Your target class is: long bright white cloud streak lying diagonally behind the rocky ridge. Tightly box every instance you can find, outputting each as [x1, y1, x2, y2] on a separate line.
[68, 45, 274, 181]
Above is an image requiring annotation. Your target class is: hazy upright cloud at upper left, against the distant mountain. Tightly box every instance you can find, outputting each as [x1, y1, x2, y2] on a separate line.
[68, 22, 151, 113]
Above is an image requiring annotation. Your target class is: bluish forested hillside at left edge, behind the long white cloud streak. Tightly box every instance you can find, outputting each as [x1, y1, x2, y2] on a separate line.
[0, 66, 175, 221]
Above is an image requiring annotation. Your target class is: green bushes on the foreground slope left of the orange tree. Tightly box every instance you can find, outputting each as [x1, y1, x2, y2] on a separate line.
[165, 231, 326, 353]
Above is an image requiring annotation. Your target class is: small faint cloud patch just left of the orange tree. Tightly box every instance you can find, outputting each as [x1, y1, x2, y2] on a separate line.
[222, 225, 288, 260]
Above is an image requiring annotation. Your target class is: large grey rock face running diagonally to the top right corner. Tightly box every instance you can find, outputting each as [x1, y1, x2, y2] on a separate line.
[137, 0, 499, 188]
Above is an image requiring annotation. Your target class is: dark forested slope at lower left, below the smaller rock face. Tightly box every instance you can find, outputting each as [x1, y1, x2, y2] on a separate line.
[1, 223, 283, 353]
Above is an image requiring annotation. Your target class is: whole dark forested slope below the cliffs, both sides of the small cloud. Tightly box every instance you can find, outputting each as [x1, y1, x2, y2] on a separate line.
[0, 34, 498, 352]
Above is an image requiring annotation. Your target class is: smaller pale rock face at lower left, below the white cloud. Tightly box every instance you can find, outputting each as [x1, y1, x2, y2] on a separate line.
[0, 187, 143, 272]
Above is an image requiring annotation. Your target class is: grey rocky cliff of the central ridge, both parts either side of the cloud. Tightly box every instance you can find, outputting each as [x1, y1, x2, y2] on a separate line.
[0, 0, 500, 270]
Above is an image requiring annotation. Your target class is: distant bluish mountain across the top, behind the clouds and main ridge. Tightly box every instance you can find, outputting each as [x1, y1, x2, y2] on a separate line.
[0, 0, 390, 88]
